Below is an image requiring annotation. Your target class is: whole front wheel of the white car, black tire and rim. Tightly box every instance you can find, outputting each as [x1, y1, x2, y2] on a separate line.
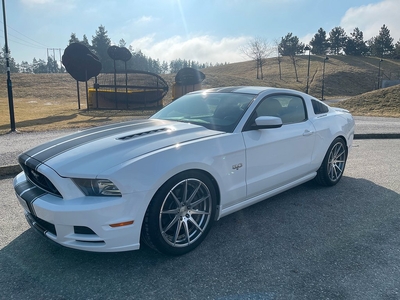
[141, 171, 216, 255]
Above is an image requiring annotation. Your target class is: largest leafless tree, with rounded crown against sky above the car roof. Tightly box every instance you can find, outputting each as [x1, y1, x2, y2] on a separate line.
[241, 38, 274, 79]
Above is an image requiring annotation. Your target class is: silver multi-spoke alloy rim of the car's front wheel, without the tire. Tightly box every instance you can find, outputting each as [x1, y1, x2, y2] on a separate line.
[159, 178, 212, 247]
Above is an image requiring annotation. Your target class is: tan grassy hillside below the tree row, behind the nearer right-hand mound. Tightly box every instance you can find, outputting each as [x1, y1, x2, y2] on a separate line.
[203, 55, 400, 98]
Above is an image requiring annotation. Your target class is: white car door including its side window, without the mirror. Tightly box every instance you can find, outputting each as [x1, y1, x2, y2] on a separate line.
[243, 94, 315, 198]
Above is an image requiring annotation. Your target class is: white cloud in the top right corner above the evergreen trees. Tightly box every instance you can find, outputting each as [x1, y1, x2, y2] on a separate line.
[340, 0, 400, 43]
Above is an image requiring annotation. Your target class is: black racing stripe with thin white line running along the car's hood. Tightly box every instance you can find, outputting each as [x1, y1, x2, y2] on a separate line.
[21, 119, 165, 162]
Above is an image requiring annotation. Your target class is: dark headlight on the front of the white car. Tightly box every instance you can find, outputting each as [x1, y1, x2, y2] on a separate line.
[73, 178, 121, 197]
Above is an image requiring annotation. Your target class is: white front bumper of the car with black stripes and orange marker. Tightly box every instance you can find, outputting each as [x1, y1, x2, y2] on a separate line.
[13, 173, 147, 252]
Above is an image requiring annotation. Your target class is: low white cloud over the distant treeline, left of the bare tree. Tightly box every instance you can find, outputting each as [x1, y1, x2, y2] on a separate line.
[131, 34, 249, 63]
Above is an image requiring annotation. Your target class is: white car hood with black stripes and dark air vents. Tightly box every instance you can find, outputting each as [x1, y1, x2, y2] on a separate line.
[19, 119, 222, 177]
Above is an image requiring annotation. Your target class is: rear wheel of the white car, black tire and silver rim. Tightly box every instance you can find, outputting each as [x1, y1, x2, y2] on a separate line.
[315, 138, 347, 186]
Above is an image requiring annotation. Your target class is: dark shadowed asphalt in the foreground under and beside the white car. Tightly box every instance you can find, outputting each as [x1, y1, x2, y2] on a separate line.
[0, 177, 400, 299]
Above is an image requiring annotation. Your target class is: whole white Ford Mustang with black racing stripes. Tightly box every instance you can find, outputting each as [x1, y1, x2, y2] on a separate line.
[14, 87, 355, 255]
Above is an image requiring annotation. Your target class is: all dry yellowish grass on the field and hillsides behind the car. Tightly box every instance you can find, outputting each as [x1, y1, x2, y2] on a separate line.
[0, 56, 400, 133]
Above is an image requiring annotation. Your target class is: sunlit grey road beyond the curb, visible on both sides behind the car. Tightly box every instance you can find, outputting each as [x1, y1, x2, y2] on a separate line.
[0, 117, 400, 176]
